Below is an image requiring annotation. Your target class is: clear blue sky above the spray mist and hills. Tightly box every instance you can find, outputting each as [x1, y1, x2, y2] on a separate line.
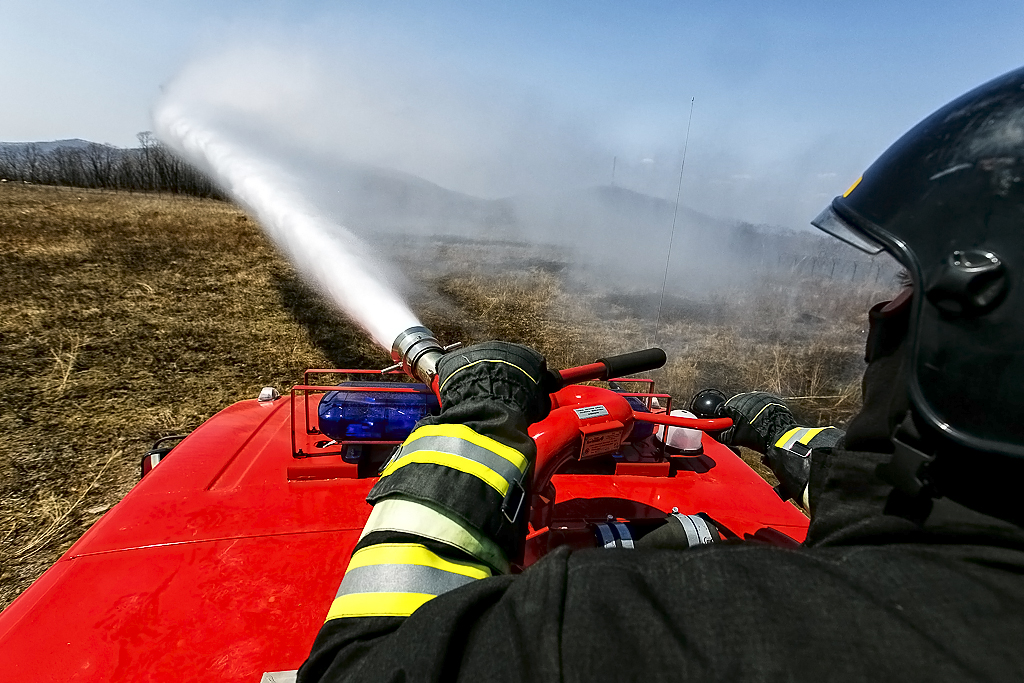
[0, 0, 1024, 224]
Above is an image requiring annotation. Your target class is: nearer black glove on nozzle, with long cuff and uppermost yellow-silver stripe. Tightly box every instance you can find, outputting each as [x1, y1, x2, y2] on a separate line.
[367, 341, 552, 558]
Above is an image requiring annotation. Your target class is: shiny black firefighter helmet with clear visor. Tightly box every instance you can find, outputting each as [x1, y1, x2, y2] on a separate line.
[812, 69, 1024, 509]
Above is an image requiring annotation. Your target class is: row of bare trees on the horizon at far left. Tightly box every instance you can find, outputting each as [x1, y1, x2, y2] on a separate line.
[0, 132, 225, 199]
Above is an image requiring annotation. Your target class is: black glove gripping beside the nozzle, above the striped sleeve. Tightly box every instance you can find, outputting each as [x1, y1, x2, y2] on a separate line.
[437, 341, 558, 425]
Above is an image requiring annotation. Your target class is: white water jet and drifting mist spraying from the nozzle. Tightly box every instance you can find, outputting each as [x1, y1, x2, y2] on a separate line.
[156, 42, 872, 327]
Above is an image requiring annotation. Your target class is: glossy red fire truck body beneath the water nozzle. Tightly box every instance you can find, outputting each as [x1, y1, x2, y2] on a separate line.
[0, 376, 807, 683]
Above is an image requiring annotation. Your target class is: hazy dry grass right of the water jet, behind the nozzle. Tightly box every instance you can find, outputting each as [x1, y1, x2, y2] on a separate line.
[407, 246, 891, 425]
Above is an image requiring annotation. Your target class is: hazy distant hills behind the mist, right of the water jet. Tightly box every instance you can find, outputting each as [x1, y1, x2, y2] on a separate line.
[321, 168, 895, 289]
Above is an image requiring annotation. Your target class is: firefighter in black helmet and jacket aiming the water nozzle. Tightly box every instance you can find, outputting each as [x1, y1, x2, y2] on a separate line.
[299, 69, 1024, 682]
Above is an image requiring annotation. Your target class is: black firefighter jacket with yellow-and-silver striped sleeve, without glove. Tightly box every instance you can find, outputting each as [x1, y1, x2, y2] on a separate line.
[299, 342, 1024, 683]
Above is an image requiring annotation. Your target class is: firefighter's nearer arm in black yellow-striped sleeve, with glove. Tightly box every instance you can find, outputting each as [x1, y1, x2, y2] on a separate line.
[299, 342, 549, 681]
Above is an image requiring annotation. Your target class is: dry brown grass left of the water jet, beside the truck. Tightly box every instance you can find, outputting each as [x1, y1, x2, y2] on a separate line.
[0, 183, 387, 605]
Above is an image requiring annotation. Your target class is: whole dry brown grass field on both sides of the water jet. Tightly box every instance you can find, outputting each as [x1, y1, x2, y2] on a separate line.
[0, 183, 883, 606]
